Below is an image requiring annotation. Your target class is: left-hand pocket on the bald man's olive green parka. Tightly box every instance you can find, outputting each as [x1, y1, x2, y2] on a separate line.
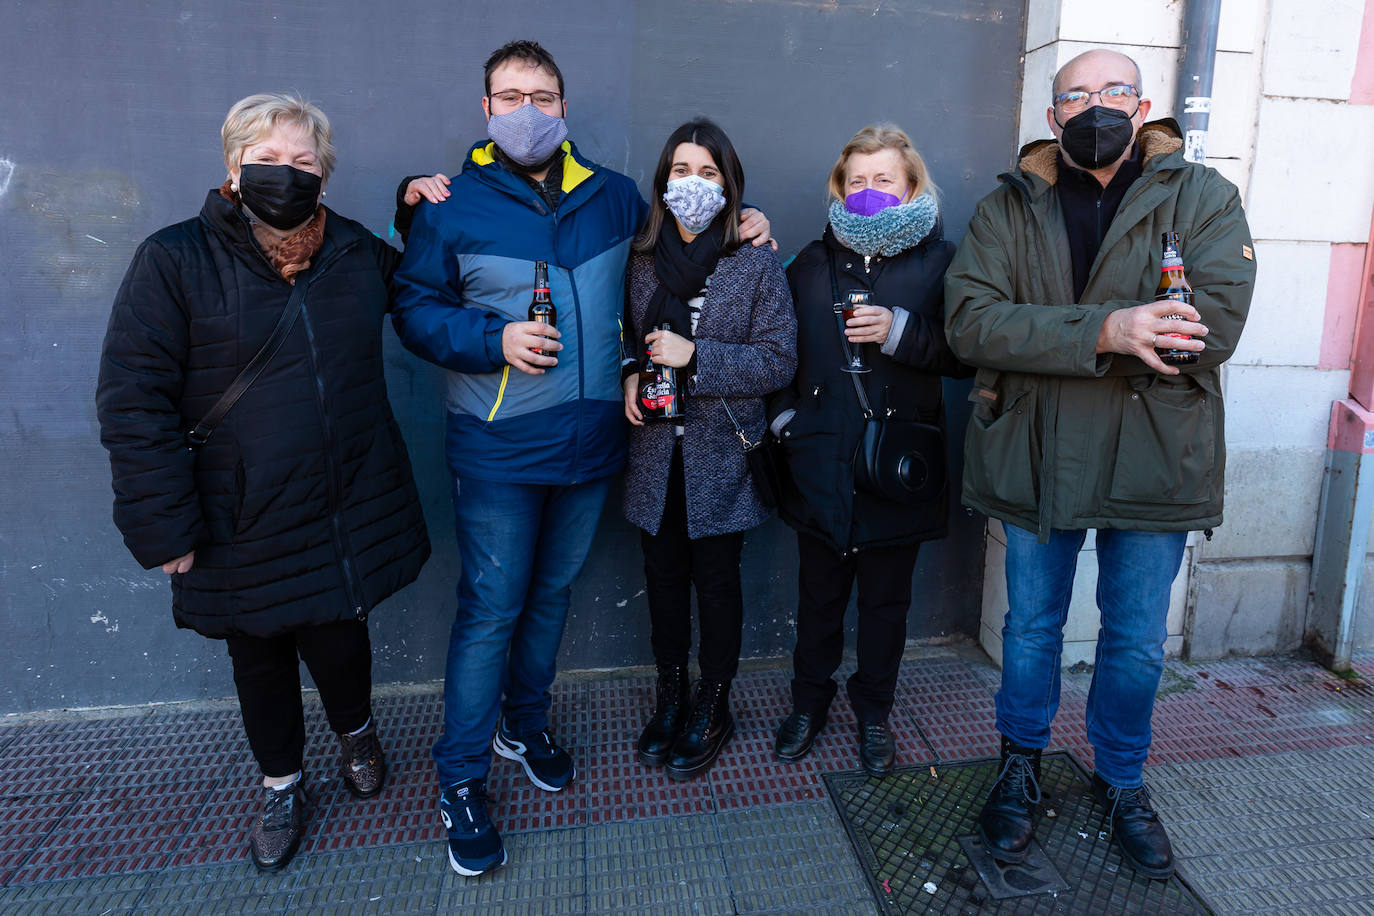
[963, 376, 1040, 511]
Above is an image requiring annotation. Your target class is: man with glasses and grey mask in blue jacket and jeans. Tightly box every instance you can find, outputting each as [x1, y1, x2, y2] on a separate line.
[393, 41, 768, 876]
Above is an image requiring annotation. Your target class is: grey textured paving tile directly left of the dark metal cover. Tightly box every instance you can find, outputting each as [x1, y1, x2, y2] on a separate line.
[716, 801, 874, 915]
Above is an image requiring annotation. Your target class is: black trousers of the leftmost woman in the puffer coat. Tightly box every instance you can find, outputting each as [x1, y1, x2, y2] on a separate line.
[225, 621, 372, 776]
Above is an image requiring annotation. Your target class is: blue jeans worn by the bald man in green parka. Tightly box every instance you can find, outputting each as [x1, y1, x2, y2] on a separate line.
[996, 525, 1187, 788]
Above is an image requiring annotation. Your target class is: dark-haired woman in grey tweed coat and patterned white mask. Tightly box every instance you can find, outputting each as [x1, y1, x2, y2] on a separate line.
[625, 121, 797, 779]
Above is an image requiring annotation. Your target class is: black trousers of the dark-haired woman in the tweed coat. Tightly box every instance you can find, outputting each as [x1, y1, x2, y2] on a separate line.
[640, 444, 745, 681]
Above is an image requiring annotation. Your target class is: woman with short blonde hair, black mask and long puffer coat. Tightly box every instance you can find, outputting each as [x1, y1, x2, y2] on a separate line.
[96, 93, 442, 871]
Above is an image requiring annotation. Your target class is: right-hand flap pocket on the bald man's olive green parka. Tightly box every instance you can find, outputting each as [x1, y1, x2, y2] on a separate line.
[1109, 376, 1219, 505]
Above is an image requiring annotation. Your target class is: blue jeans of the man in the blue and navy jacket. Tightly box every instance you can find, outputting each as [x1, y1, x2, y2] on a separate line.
[434, 477, 610, 786]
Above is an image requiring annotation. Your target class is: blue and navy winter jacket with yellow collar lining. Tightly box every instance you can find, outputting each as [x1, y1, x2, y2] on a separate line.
[393, 143, 646, 485]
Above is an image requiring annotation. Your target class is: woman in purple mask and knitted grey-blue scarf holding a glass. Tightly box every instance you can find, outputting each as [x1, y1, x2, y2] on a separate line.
[768, 124, 971, 777]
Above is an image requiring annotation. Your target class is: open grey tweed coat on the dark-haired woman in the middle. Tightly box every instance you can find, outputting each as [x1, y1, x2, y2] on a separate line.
[624, 243, 797, 538]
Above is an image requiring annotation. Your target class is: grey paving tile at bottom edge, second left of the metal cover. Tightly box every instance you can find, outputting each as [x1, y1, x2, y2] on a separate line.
[587, 814, 735, 915]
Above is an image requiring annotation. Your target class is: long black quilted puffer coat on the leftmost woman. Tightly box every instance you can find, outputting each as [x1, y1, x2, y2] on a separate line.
[96, 191, 430, 637]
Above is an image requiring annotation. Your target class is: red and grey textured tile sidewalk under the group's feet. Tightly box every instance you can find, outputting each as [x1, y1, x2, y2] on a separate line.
[0, 647, 1374, 916]
